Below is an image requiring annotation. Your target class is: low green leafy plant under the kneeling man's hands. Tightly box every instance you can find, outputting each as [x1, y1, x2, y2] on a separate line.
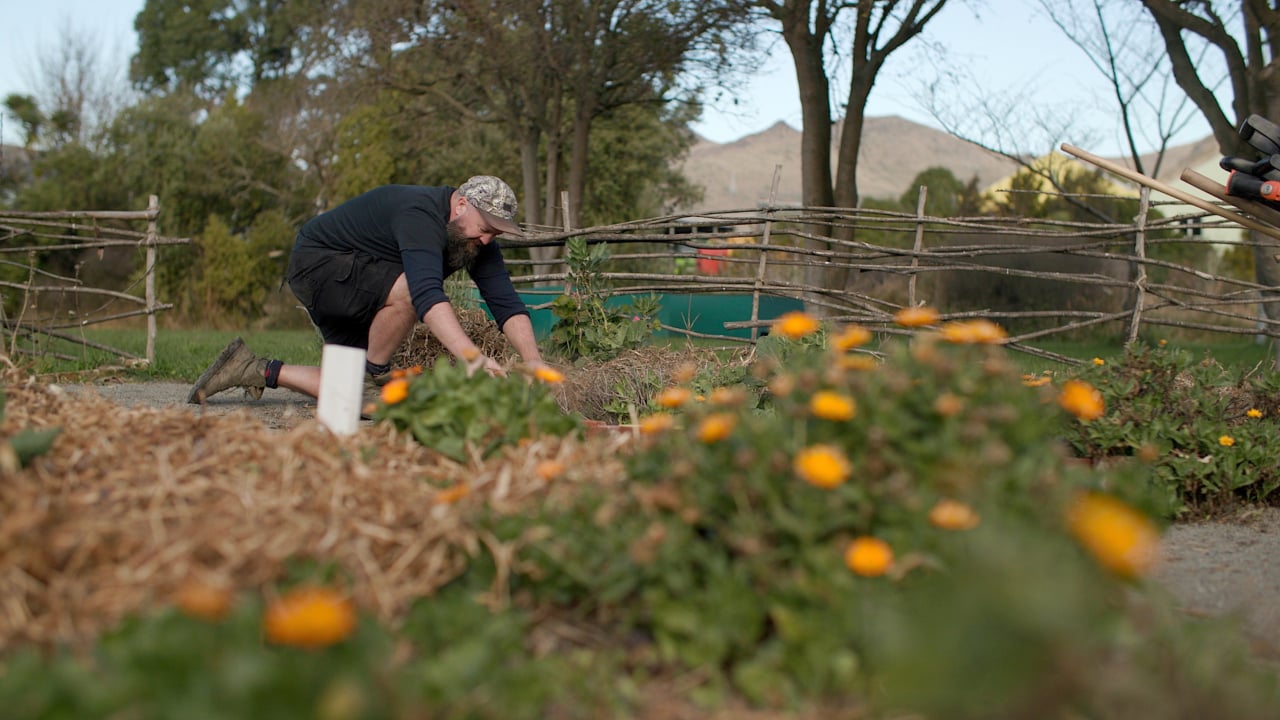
[372, 363, 582, 462]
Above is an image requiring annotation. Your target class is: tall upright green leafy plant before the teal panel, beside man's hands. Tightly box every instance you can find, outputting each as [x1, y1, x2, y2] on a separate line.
[544, 237, 660, 361]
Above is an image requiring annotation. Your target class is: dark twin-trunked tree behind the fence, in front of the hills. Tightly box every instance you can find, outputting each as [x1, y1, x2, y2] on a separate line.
[756, 0, 947, 311]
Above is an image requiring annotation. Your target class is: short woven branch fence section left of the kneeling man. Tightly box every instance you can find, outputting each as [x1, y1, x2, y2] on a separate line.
[0, 195, 191, 364]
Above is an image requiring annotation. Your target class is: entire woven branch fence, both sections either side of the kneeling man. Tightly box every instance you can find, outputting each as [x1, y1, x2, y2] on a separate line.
[0, 187, 1280, 363]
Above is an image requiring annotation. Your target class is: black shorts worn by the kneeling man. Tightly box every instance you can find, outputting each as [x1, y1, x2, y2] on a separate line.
[285, 249, 404, 350]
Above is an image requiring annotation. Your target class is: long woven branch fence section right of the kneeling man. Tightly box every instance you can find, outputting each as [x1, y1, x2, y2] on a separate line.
[503, 187, 1280, 363]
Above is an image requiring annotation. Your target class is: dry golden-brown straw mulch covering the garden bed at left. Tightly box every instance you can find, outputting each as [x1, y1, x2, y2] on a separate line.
[0, 370, 630, 652]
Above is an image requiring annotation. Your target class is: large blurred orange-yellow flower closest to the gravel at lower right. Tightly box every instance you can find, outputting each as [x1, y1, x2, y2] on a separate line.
[1066, 492, 1160, 578]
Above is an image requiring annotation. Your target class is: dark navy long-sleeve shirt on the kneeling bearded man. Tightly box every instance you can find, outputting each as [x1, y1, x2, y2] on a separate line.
[296, 184, 529, 328]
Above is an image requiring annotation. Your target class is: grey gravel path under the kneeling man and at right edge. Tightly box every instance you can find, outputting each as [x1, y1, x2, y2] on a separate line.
[64, 382, 1280, 659]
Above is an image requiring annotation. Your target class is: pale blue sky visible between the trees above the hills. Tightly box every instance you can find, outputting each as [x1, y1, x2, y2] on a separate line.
[0, 0, 1208, 155]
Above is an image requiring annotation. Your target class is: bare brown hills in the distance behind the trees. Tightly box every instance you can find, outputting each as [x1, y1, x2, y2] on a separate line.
[681, 115, 1217, 213]
